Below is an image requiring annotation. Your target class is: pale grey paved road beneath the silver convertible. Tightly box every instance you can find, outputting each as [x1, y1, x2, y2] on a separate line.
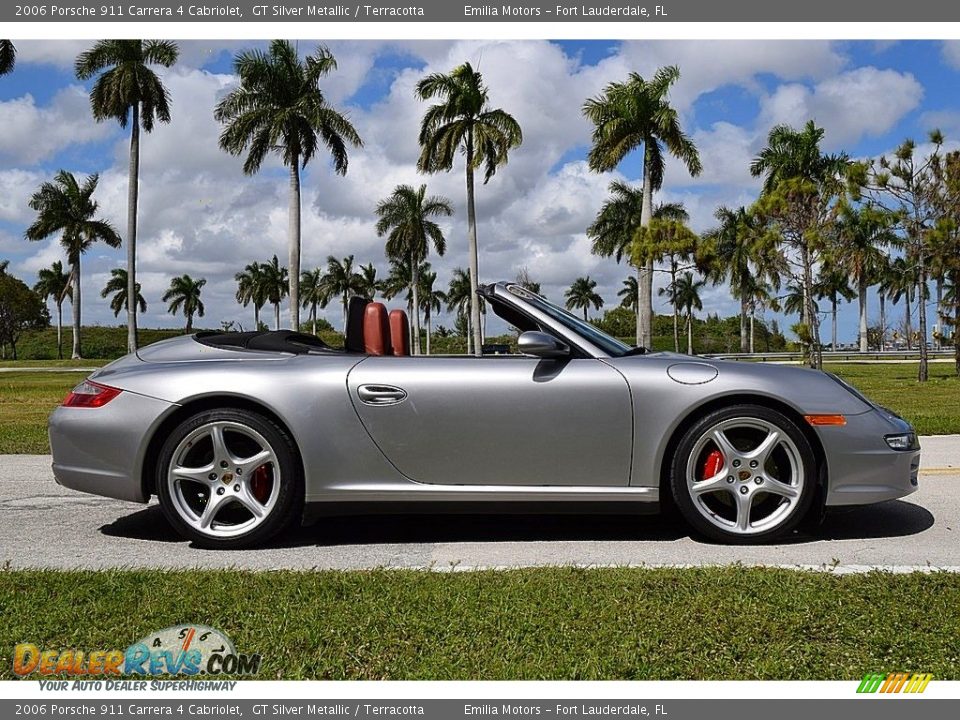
[0, 435, 960, 571]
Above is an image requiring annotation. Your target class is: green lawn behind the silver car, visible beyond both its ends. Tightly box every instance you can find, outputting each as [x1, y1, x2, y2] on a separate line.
[0, 360, 960, 454]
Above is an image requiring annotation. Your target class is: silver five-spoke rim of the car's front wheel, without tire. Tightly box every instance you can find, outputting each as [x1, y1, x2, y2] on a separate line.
[686, 417, 805, 535]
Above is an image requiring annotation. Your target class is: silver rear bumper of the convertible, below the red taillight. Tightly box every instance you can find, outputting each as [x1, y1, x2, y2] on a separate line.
[48, 392, 176, 502]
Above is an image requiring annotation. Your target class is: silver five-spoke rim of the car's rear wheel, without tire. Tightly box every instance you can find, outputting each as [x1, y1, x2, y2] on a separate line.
[167, 420, 282, 538]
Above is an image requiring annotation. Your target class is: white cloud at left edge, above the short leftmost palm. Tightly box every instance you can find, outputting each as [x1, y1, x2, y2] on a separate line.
[0, 85, 114, 164]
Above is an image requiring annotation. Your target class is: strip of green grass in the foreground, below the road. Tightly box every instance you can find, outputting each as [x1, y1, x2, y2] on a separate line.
[0, 566, 960, 681]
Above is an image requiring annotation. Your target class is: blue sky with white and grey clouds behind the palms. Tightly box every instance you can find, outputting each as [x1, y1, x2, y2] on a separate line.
[0, 41, 960, 342]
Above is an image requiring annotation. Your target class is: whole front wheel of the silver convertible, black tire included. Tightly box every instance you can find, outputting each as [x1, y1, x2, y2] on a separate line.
[670, 405, 817, 543]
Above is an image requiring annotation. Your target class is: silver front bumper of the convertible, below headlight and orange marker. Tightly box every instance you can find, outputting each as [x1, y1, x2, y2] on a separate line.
[818, 410, 920, 506]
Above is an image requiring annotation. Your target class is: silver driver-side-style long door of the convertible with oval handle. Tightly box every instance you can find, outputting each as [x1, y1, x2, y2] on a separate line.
[347, 356, 633, 486]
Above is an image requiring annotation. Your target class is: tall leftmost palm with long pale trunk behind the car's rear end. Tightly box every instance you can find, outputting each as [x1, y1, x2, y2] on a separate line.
[75, 40, 180, 352]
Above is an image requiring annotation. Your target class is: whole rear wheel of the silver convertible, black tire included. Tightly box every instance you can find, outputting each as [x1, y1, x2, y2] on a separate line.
[156, 409, 303, 549]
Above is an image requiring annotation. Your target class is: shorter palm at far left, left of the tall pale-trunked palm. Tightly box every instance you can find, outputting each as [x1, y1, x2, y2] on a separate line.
[24, 170, 120, 359]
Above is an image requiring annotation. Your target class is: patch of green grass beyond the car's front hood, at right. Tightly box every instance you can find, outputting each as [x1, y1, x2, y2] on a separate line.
[825, 363, 960, 435]
